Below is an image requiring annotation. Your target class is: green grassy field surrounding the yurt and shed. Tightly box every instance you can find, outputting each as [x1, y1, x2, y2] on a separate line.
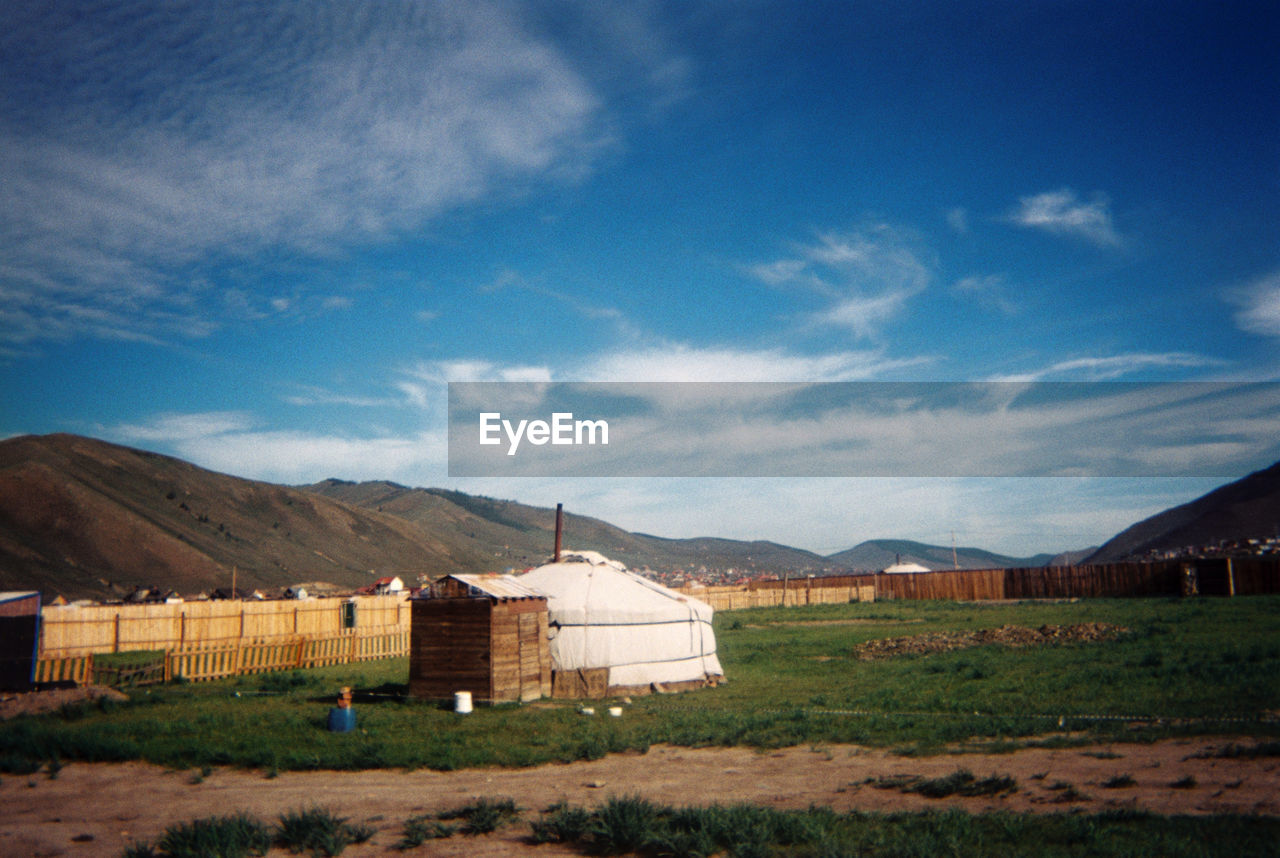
[0, 597, 1280, 773]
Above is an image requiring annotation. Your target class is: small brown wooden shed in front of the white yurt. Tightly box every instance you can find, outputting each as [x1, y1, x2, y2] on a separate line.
[408, 574, 552, 703]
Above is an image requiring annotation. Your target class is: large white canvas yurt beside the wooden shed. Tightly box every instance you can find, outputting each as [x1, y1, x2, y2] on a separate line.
[518, 551, 724, 697]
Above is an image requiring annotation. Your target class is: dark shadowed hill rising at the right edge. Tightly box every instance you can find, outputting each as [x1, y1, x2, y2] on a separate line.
[1085, 462, 1280, 563]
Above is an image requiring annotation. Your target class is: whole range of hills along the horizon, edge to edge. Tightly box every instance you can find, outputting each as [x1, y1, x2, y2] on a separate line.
[0, 434, 1280, 599]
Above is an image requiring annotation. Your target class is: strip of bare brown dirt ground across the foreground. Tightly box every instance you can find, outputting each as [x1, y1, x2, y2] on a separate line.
[0, 738, 1280, 858]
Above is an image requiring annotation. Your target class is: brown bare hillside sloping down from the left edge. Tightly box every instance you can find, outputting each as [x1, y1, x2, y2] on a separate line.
[0, 434, 488, 598]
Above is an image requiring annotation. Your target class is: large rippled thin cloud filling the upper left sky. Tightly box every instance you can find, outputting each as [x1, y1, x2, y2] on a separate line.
[0, 1, 607, 346]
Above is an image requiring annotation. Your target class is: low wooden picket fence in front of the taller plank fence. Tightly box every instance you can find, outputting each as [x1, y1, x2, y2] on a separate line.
[36, 629, 410, 685]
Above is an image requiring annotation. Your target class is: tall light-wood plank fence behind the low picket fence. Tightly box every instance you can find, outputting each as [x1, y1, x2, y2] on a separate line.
[40, 595, 410, 658]
